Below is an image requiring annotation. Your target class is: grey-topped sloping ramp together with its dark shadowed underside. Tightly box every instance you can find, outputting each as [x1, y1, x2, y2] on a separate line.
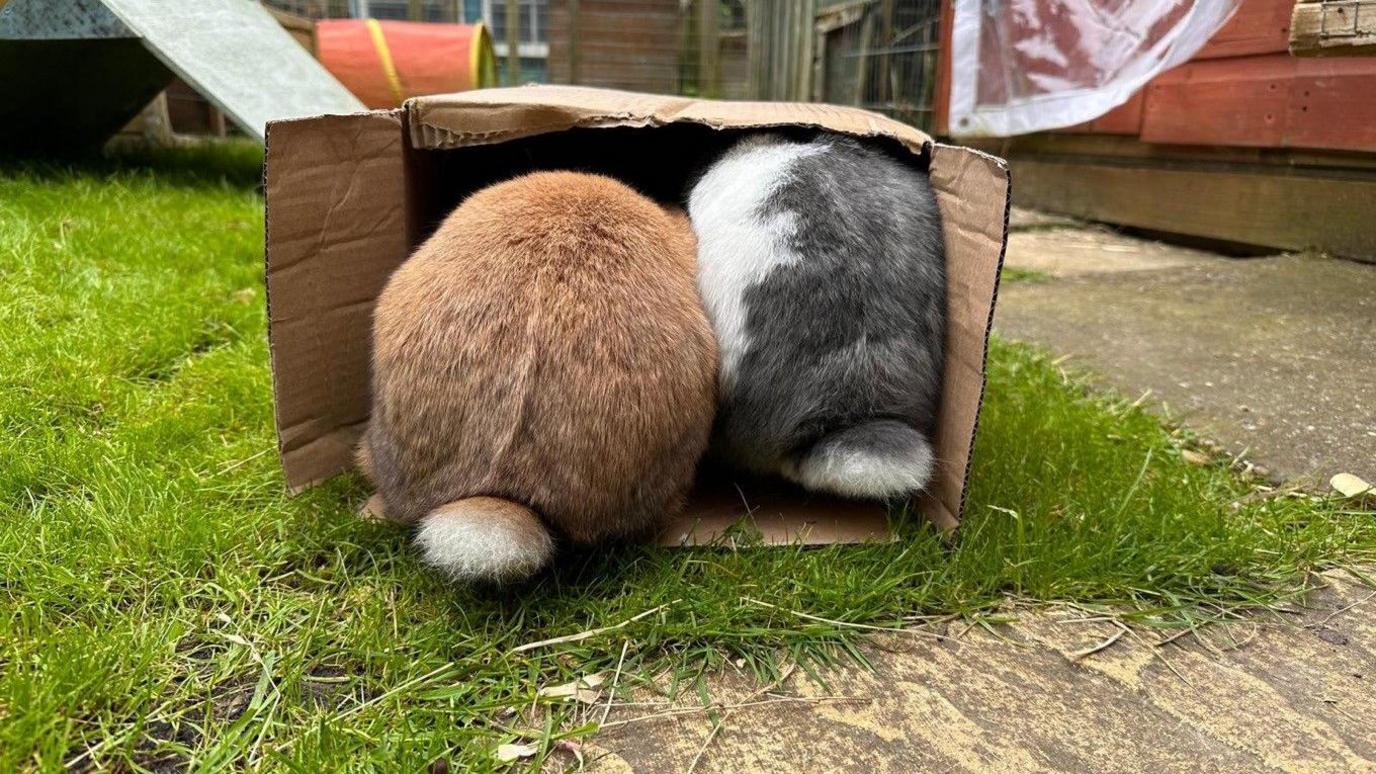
[0, 0, 363, 150]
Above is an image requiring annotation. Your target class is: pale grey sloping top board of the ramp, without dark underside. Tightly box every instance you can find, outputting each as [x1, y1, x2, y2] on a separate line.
[105, 0, 366, 142]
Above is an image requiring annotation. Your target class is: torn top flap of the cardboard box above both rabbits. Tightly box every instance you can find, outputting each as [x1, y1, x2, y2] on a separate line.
[406, 85, 932, 153]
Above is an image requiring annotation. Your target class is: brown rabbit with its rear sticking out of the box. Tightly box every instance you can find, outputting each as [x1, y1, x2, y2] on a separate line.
[359, 172, 717, 580]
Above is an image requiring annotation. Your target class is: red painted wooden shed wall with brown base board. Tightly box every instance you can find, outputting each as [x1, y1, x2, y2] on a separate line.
[937, 0, 1376, 260]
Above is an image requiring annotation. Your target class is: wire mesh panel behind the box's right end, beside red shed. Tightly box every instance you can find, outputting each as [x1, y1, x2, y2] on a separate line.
[812, 0, 941, 131]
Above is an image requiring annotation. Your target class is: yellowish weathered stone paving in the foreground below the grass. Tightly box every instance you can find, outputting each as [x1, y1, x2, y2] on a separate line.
[585, 573, 1376, 774]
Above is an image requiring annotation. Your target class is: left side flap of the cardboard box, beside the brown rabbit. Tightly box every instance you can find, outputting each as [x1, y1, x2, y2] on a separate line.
[263, 110, 410, 492]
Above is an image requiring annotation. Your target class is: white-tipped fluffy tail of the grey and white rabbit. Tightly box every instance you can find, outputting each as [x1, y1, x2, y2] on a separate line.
[786, 420, 936, 500]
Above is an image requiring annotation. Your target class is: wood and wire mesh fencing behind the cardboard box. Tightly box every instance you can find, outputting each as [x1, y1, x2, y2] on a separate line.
[258, 0, 941, 129]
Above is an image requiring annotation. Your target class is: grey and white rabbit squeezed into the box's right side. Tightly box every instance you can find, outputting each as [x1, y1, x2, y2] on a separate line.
[688, 134, 947, 500]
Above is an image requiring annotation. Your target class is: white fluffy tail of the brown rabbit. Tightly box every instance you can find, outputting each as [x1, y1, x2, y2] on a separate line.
[416, 497, 555, 581]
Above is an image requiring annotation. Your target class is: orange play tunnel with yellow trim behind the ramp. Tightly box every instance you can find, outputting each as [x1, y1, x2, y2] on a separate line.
[315, 19, 497, 109]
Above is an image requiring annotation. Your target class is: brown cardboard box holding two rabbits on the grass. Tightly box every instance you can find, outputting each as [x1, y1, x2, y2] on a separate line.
[266, 87, 1009, 544]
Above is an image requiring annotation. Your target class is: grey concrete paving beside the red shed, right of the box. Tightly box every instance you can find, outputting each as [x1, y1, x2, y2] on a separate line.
[995, 216, 1376, 485]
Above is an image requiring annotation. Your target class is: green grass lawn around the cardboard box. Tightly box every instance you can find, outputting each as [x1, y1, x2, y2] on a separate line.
[0, 143, 1376, 773]
